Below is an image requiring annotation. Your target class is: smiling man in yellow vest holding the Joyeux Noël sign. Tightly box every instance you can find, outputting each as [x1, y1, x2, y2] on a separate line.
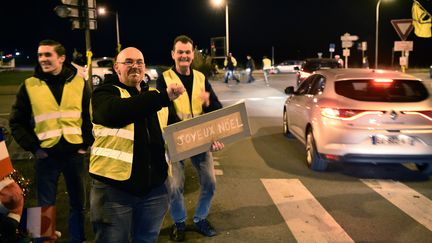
[156, 35, 224, 241]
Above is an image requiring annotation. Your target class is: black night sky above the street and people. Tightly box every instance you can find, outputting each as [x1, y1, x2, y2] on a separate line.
[0, 0, 432, 67]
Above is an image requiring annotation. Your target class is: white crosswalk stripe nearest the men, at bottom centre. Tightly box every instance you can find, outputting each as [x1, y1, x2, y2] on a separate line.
[261, 179, 354, 242]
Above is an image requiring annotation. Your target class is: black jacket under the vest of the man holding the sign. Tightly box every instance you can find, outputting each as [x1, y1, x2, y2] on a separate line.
[156, 68, 222, 125]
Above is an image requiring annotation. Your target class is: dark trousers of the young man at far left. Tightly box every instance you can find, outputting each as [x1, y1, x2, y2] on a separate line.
[36, 153, 88, 242]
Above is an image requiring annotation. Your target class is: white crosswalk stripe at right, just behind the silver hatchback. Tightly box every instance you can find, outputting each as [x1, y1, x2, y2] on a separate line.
[361, 179, 432, 231]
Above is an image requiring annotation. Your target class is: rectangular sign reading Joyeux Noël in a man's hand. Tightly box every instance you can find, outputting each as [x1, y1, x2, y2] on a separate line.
[164, 103, 250, 162]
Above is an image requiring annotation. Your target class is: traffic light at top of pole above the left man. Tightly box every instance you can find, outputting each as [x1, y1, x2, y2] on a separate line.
[54, 0, 97, 30]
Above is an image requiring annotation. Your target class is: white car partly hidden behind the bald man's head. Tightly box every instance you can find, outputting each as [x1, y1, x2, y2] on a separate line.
[72, 57, 159, 86]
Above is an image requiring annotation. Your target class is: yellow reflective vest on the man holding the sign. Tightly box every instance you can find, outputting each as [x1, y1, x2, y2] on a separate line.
[163, 69, 205, 120]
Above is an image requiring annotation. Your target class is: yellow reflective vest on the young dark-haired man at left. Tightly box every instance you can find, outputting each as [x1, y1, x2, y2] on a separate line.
[24, 76, 84, 148]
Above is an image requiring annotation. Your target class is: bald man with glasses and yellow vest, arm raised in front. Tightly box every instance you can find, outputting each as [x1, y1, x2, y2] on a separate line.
[90, 47, 184, 243]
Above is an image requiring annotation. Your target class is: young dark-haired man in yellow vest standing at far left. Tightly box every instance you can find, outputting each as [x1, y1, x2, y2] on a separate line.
[9, 40, 93, 242]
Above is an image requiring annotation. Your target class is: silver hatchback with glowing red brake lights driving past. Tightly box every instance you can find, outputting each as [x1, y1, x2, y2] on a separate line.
[283, 69, 432, 174]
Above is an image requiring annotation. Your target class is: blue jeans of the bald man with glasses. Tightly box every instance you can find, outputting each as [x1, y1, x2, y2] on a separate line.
[90, 180, 169, 243]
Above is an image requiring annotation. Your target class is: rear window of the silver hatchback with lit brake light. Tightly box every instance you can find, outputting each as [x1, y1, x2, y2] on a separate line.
[335, 79, 429, 102]
